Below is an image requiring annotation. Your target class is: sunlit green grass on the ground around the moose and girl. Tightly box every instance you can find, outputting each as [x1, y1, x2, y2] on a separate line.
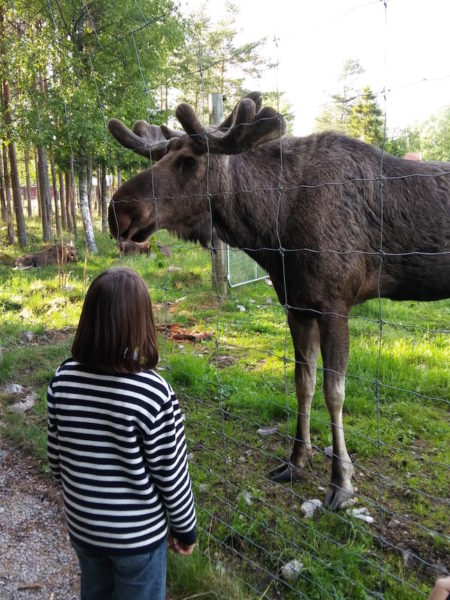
[0, 218, 450, 600]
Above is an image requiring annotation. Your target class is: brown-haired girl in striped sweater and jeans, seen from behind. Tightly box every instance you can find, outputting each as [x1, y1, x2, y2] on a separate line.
[48, 267, 196, 600]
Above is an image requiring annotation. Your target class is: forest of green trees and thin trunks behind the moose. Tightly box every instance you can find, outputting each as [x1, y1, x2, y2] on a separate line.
[0, 0, 450, 253]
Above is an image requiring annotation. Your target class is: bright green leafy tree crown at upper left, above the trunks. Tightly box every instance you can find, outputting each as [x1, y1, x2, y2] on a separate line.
[1, 0, 184, 168]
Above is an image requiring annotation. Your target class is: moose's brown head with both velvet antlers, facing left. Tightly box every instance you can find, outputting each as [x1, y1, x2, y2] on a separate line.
[108, 92, 286, 246]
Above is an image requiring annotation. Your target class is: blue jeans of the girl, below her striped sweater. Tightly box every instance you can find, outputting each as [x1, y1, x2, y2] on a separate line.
[72, 541, 167, 600]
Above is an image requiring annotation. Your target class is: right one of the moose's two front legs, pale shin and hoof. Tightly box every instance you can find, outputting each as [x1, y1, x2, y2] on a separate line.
[319, 314, 353, 510]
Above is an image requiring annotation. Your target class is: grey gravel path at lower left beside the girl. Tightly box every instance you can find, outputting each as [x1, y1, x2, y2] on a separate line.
[0, 438, 79, 600]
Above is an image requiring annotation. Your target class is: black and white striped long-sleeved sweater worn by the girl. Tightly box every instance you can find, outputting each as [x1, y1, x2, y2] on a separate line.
[47, 359, 196, 554]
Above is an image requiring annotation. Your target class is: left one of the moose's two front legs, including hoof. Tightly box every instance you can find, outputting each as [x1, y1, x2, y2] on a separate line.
[270, 312, 319, 481]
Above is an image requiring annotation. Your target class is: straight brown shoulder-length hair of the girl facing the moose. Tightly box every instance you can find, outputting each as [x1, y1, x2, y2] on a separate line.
[72, 267, 158, 373]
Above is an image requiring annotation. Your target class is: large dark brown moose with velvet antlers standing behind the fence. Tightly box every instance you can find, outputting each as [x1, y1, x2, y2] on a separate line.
[108, 92, 450, 510]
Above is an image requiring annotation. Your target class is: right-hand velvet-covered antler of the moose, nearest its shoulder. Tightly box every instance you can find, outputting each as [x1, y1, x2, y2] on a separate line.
[175, 93, 286, 154]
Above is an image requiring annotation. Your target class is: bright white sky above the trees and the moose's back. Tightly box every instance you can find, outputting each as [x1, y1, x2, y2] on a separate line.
[181, 0, 450, 135]
